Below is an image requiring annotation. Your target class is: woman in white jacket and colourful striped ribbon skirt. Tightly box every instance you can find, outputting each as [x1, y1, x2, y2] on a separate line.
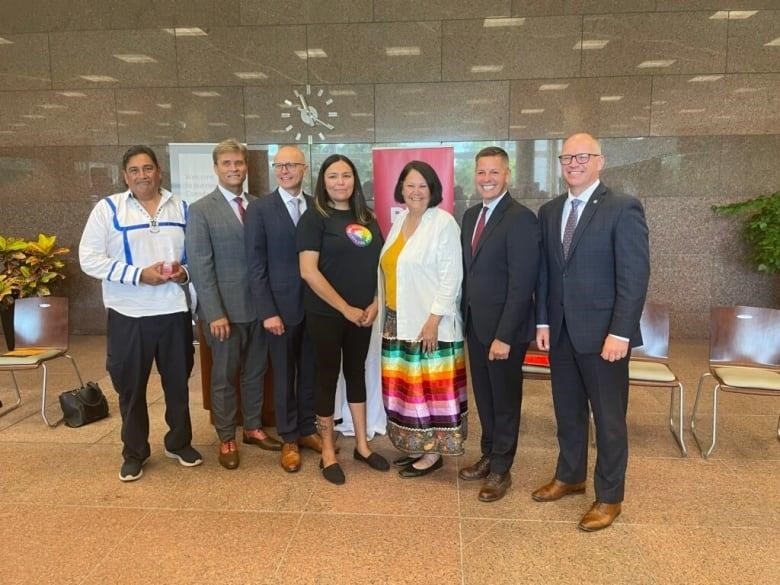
[378, 161, 467, 477]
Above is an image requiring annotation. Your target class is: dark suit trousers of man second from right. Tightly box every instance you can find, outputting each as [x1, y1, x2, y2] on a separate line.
[466, 320, 528, 474]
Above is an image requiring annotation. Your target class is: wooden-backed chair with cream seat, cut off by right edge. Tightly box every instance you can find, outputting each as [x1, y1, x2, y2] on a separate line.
[691, 306, 780, 458]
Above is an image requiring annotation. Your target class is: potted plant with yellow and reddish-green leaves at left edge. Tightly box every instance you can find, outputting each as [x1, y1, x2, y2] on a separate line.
[0, 234, 70, 349]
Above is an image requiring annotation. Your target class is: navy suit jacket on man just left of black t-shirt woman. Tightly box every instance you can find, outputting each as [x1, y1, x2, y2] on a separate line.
[245, 189, 314, 325]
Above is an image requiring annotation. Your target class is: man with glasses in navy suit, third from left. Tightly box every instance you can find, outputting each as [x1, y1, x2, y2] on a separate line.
[245, 146, 322, 473]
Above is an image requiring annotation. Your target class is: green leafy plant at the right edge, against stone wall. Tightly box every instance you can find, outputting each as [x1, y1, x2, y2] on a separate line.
[712, 191, 780, 274]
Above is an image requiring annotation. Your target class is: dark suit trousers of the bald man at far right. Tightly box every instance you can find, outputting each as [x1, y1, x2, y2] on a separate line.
[550, 322, 630, 504]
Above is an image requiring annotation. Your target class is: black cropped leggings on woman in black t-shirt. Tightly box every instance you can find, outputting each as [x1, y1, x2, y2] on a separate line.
[306, 313, 371, 417]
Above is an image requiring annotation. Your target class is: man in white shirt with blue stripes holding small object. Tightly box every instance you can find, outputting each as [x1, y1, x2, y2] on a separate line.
[79, 146, 203, 481]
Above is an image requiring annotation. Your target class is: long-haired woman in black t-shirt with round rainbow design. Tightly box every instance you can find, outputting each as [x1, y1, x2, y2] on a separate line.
[297, 154, 390, 484]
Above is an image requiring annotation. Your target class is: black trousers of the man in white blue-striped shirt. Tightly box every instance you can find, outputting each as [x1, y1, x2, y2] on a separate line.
[106, 309, 195, 461]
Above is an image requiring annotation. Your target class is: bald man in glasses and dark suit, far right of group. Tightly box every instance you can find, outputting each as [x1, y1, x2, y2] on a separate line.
[532, 134, 650, 532]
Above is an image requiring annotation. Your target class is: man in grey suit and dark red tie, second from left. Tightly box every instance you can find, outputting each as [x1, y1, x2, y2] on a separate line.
[185, 139, 281, 469]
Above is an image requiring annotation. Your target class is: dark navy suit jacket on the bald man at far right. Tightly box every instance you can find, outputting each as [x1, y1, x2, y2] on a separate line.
[536, 183, 650, 353]
